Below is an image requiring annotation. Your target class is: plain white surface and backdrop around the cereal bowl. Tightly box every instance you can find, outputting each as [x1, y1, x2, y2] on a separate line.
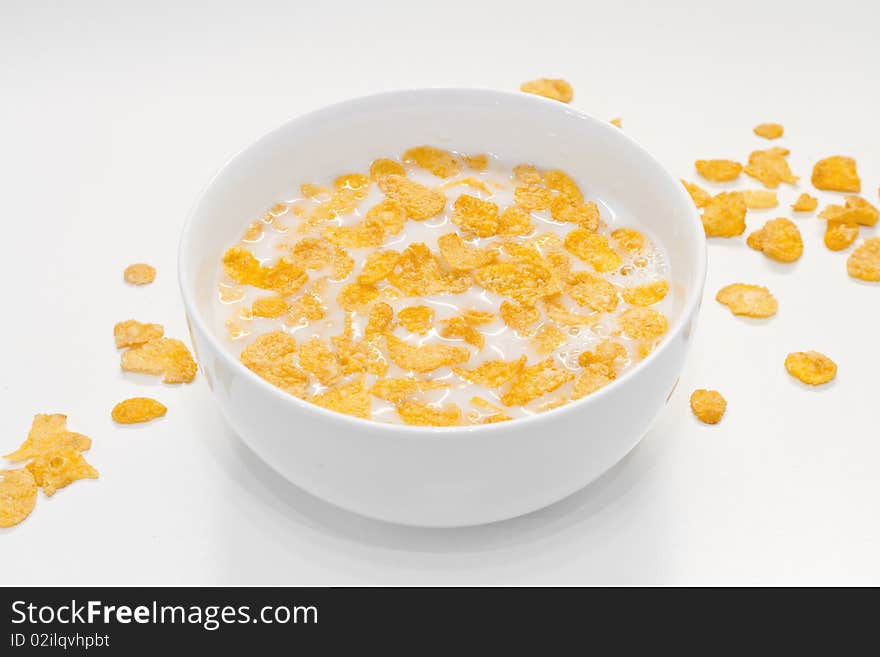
[0, 0, 880, 585]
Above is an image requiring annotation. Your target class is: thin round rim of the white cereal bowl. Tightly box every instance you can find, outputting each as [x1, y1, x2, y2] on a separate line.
[177, 87, 707, 438]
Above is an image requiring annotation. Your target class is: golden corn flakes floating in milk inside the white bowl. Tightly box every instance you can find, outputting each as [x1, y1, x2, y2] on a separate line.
[215, 146, 673, 426]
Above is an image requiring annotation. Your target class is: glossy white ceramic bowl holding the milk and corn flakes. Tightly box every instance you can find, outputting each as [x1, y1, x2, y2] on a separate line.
[179, 89, 706, 527]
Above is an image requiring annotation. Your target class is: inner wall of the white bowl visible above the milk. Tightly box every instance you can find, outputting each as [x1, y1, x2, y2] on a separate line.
[182, 90, 704, 338]
